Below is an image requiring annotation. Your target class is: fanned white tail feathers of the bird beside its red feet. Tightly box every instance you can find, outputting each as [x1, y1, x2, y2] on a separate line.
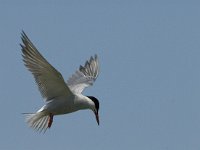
[25, 112, 49, 132]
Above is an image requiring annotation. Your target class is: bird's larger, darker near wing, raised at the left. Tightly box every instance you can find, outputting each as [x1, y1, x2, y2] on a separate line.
[20, 32, 71, 101]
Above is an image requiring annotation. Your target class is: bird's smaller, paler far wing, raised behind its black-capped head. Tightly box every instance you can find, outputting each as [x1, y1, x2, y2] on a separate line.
[67, 55, 99, 94]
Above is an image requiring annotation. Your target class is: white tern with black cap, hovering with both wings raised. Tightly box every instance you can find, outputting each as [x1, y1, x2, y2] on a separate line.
[20, 31, 99, 132]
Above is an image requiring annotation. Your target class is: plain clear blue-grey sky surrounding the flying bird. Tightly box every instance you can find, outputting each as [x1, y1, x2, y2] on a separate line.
[0, 0, 200, 150]
